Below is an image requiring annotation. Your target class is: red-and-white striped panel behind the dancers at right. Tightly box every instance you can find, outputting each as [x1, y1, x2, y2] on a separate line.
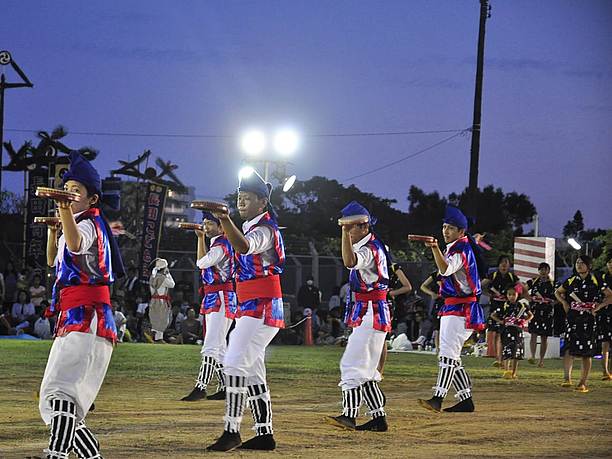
[514, 237, 555, 282]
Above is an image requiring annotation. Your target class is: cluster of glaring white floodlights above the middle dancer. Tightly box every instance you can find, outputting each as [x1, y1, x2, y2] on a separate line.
[240, 129, 300, 187]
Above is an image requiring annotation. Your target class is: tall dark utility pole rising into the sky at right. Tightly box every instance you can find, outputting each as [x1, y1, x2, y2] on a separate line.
[468, 0, 491, 217]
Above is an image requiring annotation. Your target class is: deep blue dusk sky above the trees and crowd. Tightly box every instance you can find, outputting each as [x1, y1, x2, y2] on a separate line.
[0, 0, 612, 236]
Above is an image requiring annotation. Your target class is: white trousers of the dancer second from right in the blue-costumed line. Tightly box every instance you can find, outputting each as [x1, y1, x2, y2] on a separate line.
[338, 302, 387, 390]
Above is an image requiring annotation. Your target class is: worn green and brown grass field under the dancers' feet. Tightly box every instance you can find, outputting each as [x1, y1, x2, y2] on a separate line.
[0, 341, 612, 459]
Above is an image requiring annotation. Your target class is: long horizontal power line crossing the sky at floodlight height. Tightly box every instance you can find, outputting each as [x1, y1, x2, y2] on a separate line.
[5, 129, 463, 139]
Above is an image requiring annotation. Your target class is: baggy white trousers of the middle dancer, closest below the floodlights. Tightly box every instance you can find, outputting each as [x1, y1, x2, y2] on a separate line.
[223, 316, 278, 386]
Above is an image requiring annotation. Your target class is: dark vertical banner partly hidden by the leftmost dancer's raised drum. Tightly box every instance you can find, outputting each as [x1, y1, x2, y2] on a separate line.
[25, 167, 49, 270]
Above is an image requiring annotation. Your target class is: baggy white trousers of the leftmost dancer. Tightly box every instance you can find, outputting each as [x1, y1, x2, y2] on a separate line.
[38, 313, 113, 424]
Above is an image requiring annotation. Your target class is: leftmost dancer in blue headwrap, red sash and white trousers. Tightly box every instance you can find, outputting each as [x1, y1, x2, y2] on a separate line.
[39, 152, 123, 459]
